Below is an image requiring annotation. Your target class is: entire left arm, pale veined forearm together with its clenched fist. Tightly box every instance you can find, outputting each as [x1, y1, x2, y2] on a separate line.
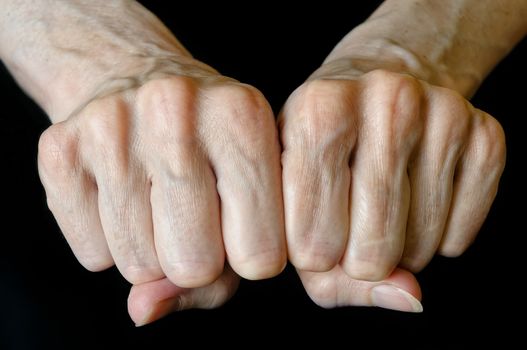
[0, 0, 286, 323]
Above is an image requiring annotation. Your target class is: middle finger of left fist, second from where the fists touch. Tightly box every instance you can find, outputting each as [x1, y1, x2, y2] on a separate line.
[139, 78, 225, 288]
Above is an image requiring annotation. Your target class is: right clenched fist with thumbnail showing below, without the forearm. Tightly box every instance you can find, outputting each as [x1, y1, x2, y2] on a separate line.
[280, 70, 505, 311]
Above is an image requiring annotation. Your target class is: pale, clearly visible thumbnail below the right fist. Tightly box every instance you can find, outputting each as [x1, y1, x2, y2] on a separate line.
[371, 284, 423, 312]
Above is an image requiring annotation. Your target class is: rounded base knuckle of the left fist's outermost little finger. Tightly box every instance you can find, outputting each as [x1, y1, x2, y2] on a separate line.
[38, 124, 78, 177]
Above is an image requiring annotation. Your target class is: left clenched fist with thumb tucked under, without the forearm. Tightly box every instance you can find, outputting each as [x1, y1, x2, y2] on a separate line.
[39, 64, 286, 323]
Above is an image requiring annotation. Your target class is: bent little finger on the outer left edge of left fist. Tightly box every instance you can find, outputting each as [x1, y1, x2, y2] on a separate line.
[38, 123, 113, 271]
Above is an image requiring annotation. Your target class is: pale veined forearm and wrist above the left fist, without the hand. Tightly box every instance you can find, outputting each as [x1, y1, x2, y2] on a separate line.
[0, 0, 212, 122]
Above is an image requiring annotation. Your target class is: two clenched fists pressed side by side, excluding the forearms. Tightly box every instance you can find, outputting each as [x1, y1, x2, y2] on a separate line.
[39, 55, 505, 324]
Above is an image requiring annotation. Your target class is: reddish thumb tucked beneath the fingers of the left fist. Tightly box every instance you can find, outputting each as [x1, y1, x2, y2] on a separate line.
[128, 266, 239, 326]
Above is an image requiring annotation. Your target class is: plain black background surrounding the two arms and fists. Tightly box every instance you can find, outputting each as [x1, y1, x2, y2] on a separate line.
[0, 1, 527, 349]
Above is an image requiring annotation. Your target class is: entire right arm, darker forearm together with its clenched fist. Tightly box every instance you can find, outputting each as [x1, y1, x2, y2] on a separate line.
[280, 1, 527, 311]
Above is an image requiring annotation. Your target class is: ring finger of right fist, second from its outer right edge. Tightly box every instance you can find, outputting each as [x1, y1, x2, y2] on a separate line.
[400, 88, 470, 272]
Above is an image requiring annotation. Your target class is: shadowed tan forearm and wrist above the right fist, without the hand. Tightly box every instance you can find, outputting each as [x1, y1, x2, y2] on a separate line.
[316, 0, 527, 96]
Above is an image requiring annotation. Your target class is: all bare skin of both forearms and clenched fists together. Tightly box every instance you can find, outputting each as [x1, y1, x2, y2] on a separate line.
[0, 0, 527, 325]
